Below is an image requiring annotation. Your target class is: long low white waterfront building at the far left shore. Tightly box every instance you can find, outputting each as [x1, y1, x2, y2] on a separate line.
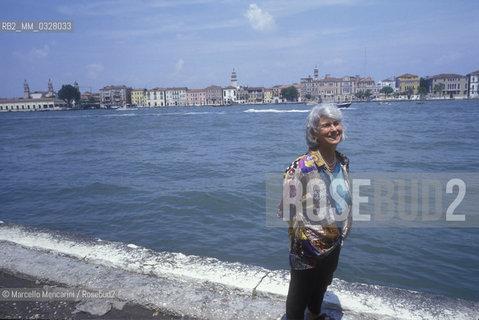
[0, 97, 67, 112]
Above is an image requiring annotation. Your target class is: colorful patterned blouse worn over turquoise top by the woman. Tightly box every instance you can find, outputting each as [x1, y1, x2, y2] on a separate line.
[278, 150, 352, 270]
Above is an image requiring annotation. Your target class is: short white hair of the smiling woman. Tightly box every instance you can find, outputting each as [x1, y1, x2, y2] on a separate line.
[306, 103, 344, 149]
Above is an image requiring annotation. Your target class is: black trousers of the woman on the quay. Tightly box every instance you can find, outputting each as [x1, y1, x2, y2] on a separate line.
[286, 246, 341, 320]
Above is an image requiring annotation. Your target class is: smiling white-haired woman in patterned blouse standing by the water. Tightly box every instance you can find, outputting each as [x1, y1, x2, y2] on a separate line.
[278, 104, 352, 320]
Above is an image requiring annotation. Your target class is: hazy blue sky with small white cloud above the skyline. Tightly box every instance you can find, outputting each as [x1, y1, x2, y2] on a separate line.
[0, 0, 479, 98]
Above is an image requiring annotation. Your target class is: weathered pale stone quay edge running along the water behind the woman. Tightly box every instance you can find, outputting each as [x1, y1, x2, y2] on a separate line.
[0, 223, 479, 320]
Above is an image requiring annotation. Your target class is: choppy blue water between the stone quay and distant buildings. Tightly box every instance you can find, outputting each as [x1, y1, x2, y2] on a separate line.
[0, 100, 479, 300]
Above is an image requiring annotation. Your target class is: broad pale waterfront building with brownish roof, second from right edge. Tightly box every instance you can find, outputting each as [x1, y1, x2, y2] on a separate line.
[426, 73, 467, 99]
